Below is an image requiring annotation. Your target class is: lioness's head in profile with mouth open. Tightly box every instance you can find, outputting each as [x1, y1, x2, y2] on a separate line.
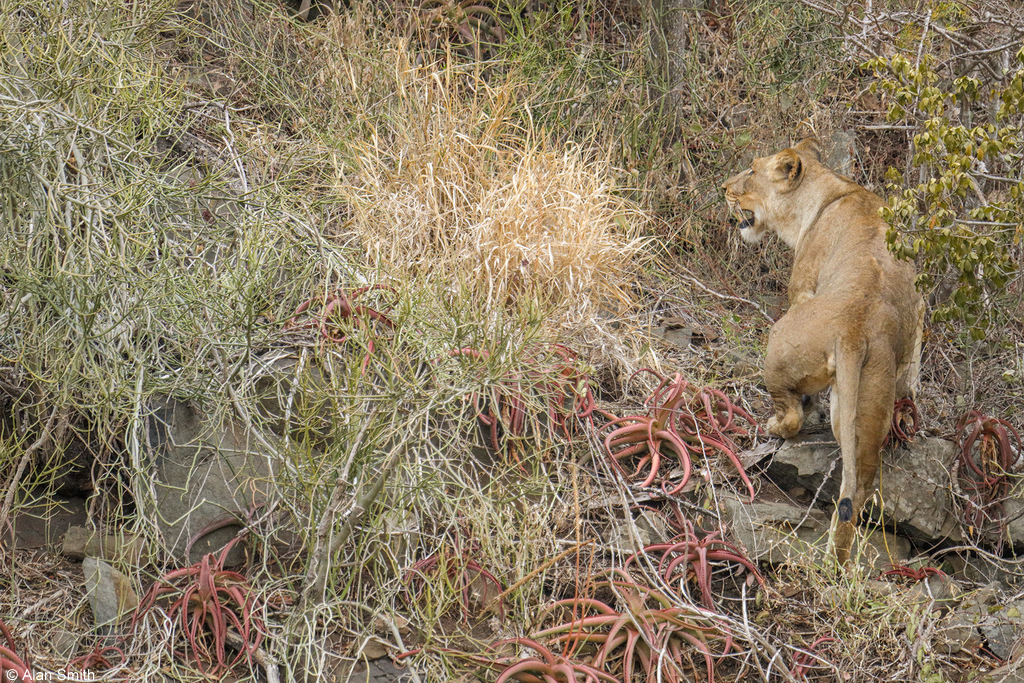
[722, 138, 818, 243]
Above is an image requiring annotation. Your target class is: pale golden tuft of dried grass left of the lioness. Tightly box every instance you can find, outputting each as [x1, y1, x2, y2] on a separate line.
[336, 55, 646, 323]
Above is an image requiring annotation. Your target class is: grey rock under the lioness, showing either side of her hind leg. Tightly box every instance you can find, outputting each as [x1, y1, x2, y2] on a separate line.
[768, 432, 964, 543]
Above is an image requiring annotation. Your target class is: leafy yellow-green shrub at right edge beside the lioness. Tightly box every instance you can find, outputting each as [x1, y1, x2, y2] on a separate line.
[867, 49, 1024, 339]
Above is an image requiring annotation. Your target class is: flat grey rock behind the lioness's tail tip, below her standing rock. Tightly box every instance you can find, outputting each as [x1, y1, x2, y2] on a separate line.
[720, 493, 910, 569]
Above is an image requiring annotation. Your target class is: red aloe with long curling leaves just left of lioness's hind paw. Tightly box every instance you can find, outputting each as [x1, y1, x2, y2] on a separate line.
[602, 368, 757, 501]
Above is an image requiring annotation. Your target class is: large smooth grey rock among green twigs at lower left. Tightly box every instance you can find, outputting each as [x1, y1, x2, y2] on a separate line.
[140, 397, 276, 565]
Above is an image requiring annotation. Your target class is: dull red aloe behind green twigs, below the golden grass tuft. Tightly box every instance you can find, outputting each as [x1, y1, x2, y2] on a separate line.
[449, 344, 595, 462]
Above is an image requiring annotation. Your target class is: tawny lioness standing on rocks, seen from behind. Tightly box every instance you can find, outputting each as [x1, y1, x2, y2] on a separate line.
[723, 138, 925, 563]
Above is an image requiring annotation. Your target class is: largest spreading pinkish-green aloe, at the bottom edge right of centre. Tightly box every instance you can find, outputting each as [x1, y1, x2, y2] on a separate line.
[534, 569, 732, 683]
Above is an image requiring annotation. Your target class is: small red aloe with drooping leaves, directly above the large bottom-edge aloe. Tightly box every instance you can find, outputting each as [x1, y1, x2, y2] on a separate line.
[625, 519, 765, 609]
